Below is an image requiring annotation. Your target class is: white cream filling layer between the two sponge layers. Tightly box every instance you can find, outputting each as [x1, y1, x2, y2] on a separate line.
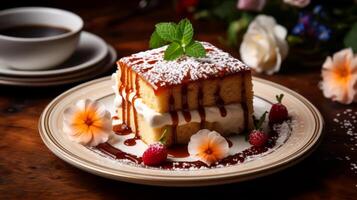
[113, 73, 244, 133]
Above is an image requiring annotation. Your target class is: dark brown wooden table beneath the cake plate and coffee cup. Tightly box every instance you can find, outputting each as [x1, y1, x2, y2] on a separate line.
[0, 0, 357, 199]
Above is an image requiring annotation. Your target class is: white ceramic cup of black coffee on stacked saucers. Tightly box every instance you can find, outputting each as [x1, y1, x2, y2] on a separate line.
[0, 7, 83, 70]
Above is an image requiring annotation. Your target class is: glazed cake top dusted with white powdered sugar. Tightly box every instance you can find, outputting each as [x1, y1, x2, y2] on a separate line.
[119, 42, 250, 89]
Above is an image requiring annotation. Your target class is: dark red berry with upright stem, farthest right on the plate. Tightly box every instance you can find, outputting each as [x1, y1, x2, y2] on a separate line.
[269, 94, 288, 124]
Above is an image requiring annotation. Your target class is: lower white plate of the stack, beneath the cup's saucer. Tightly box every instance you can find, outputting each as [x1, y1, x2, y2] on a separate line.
[0, 45, 117, 87]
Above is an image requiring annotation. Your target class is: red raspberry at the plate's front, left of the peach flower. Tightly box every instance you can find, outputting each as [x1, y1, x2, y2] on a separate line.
[142, 143, 167, 166]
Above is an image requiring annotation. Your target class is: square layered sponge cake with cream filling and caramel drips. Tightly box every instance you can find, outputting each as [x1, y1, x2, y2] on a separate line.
[113, 42, 253, 145]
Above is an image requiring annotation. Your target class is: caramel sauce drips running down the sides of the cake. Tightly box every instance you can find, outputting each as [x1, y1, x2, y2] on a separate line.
[115, 59, 249, 143]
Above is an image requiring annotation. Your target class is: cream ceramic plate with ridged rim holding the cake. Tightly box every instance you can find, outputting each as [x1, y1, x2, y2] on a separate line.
[39, 77, 323, 186]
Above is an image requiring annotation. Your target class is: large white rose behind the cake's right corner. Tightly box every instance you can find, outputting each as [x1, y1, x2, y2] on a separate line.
[239, 15, 288, 75]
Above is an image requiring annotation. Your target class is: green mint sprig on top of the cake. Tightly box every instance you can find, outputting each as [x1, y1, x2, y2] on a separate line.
[150, 19, 206, 60]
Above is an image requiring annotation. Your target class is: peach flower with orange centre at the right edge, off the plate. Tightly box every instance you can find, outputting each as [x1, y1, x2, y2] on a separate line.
[320, 49, 357, 104]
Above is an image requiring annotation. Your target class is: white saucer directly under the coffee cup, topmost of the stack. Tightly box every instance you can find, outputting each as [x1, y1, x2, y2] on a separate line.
[0, 31, 108, 77]
